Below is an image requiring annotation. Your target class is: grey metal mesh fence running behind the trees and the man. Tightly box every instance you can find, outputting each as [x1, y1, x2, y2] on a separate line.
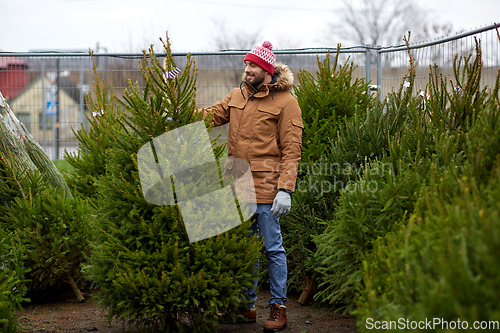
[0, 25, 500, 163]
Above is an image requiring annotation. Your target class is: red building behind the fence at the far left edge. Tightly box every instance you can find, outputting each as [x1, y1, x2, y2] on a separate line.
[0, 57, 28, 101]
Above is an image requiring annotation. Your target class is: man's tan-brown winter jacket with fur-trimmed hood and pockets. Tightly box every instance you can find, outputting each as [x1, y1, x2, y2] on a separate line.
[205, 63, 304, 204]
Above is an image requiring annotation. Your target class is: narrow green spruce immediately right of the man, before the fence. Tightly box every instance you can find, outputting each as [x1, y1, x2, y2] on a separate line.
[282, 45, 377, 296]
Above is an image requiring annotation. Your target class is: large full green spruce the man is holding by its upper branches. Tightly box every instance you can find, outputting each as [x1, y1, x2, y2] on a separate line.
[78, 37, 262, 332]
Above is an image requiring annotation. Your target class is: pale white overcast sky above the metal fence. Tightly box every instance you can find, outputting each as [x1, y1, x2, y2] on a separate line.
[0, 0, 500, 52]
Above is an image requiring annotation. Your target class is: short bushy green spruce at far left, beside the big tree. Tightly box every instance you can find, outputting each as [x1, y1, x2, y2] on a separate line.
[4, 187, 90, 301]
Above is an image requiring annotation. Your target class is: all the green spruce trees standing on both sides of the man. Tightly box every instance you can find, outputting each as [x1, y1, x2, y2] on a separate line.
[0, 30, 500, 332]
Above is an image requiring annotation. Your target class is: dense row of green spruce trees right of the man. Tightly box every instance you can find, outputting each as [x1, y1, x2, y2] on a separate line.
[283, 33, 500, 331]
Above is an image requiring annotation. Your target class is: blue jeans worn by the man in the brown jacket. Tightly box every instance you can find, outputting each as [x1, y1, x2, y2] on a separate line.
[245, 204, 288, 307]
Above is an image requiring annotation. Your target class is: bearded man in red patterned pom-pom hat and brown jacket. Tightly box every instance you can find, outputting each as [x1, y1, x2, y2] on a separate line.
[205, 42, 303, 332]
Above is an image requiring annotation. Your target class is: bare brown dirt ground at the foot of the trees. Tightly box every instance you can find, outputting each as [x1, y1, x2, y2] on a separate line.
[17, 291, 357, 333]
